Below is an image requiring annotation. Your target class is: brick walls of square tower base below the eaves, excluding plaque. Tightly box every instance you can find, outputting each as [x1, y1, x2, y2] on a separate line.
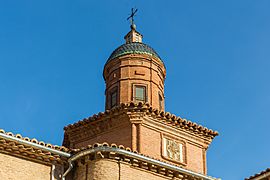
[65, 112, 211, 174]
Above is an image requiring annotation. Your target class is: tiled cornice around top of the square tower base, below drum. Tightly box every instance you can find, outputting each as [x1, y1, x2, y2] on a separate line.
[64, 102, 218, 139]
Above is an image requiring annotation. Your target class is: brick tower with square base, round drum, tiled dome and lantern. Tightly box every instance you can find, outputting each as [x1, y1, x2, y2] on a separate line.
[63, 11, 218, 179]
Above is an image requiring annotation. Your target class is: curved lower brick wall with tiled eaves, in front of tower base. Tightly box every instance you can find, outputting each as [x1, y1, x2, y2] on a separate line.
[70, 143, 215, 180]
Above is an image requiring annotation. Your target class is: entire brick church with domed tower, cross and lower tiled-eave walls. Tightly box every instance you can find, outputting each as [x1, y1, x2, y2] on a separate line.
[0, 9, 218, 180]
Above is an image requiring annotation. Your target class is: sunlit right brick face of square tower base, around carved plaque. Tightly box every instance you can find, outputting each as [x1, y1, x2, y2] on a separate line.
[139, 116, 209, 174]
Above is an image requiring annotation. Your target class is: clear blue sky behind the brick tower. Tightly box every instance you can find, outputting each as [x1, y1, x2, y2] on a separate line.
[0, 0, 270, 180]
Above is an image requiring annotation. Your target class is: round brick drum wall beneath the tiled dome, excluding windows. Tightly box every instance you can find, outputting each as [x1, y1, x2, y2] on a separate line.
[104, 54, 166, 110]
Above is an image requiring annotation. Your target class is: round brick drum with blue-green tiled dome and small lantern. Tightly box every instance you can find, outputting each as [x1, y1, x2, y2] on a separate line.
[103, 24, 166, 111]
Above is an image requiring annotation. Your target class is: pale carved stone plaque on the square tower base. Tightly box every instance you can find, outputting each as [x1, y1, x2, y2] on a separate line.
[162, 137, 184, 163]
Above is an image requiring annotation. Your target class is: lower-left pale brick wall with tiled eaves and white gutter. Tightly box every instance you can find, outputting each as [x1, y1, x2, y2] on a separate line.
[0, 129, 70, 180]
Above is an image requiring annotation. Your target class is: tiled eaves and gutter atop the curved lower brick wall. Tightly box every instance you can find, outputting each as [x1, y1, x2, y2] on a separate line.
[72, 143, 216, 180]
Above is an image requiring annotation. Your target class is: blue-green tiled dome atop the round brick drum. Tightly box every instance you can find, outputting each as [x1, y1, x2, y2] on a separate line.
[106, 42, 163, 64]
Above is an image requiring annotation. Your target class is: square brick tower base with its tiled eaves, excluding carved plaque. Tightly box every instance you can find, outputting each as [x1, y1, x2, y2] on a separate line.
[64, 102, 218, 174]
